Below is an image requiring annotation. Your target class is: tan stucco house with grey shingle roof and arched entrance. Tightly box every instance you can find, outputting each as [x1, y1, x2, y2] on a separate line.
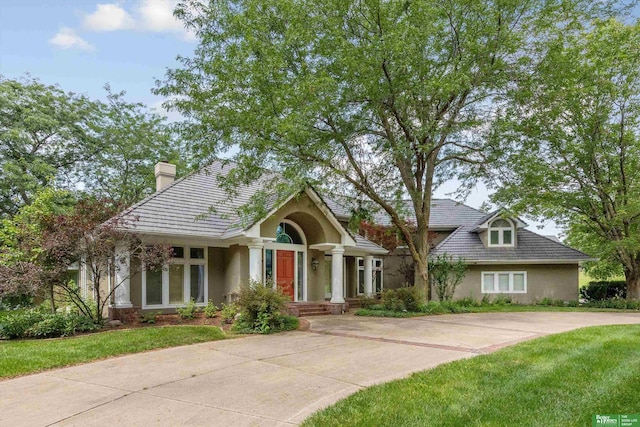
[101, 161, 589, 320]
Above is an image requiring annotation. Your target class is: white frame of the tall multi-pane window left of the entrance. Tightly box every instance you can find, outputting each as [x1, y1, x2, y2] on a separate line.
[142, 244, 209, 309]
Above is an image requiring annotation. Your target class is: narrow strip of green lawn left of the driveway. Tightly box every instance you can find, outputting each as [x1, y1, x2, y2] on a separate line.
[0, 326, 225, 378]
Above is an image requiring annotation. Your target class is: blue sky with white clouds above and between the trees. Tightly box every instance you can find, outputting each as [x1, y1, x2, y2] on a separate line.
[0, 0, 561, 235]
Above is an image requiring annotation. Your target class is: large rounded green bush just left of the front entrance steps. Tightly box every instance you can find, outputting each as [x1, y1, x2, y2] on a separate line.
[236, 282, 288, 334]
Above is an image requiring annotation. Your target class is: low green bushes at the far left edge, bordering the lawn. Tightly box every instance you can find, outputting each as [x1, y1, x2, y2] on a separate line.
[0, 309, 99, 339]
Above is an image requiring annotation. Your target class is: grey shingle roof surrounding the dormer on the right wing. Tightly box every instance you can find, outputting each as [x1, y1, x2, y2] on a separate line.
[431, 225, 591, 262]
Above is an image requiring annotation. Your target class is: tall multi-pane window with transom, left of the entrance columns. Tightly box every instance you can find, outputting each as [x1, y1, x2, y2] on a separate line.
[142, 246, 208, 308]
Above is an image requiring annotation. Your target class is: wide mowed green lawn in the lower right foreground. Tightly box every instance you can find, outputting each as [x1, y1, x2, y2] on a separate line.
[303, 325, 640, 427]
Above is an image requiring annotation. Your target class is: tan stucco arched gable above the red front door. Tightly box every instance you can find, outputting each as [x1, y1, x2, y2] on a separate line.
[260, 194, 341, 245]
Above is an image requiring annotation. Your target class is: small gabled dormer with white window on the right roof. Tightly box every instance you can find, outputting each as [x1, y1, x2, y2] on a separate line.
[472, 209, 527, 248]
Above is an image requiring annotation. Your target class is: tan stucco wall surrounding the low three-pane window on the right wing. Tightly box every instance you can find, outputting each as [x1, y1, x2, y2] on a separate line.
[444, 264, 578, 304]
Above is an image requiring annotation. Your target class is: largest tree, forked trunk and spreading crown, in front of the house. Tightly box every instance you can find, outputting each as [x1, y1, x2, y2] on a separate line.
[156, 0, 620, 295]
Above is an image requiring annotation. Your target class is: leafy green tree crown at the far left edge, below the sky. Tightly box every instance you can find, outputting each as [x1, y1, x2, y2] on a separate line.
[0, 76, 100, 217]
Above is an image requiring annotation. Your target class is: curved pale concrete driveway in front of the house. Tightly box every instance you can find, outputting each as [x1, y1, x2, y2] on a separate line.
[0, 312, 640, 426]
